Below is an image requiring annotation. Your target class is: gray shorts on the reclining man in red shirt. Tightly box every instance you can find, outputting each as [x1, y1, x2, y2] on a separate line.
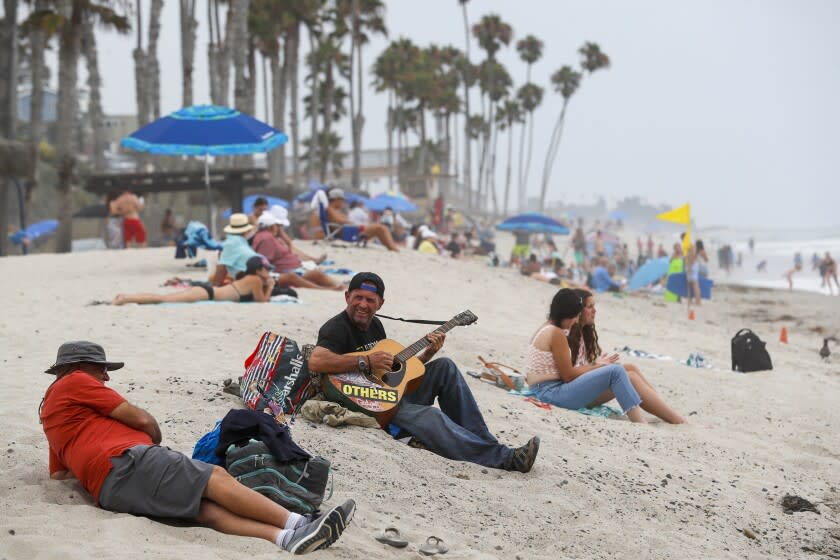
[99, 445, 213, 519]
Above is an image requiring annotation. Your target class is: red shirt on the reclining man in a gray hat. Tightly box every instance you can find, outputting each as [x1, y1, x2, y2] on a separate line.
[41, 371, 152, 503]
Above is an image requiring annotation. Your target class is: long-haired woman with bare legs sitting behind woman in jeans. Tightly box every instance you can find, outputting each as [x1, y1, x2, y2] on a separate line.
[568, 289, 685, 424]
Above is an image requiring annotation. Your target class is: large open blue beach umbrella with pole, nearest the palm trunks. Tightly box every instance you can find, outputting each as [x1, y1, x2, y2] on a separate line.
[120, 105, 288, 234]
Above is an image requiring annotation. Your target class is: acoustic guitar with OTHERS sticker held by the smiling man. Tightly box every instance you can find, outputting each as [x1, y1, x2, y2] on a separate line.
[321, 310, 478, 428]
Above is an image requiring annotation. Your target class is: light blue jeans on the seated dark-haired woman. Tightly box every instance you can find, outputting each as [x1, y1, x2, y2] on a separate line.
[531, 364, 642, 414]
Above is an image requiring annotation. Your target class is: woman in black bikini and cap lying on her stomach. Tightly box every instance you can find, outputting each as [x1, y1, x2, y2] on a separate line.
[111, 256, 274, 305]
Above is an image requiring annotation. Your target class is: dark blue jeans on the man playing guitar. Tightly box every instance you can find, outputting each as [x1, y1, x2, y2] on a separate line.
[392, 358, 513, 468]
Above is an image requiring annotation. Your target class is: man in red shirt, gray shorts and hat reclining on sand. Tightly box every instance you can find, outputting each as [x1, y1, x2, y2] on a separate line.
[39, 341, 356, 554]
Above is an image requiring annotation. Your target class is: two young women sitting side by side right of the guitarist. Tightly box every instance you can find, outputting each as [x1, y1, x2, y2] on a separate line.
[527, 288, 685, 424]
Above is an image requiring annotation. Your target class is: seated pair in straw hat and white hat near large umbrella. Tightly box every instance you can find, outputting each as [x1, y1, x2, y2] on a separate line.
[218, 212, 343, 290]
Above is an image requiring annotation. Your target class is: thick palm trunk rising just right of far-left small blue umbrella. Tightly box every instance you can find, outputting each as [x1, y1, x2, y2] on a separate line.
[56, 0, 82, 253]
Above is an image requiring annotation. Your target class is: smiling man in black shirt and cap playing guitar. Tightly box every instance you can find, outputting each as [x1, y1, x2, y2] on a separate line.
[309, 272, 540, 473]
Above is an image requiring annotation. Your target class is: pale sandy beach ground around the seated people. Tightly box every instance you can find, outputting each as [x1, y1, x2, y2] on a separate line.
[0, 243, 840, 560]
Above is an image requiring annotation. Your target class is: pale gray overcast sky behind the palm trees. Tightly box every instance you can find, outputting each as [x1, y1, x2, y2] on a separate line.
[44, 0, 840, 228]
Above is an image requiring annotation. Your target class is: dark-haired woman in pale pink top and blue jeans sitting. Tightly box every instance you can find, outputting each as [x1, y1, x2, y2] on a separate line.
[527, 288, 645, 422]
